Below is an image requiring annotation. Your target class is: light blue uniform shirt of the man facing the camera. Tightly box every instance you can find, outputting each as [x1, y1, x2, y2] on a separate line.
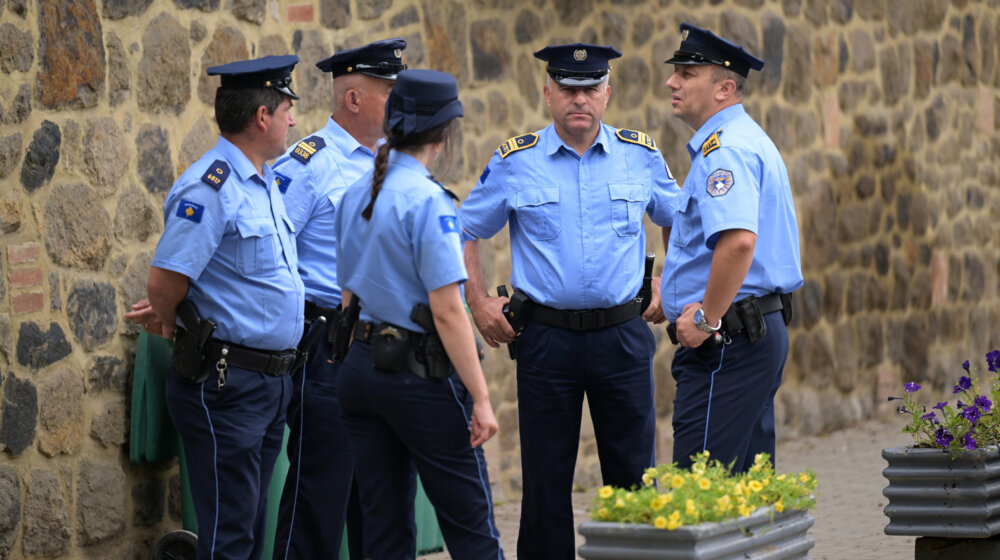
[459, 124, 679, 309]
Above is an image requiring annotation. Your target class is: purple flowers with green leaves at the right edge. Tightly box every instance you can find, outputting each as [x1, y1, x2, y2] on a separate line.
[889, 350, 1000, 453]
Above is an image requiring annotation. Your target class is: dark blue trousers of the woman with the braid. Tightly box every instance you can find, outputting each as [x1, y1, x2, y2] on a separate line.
[339, 341, 504, 560]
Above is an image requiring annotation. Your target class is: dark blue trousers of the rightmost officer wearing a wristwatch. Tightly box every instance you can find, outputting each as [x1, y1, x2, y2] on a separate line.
[670, 312, 788, 472]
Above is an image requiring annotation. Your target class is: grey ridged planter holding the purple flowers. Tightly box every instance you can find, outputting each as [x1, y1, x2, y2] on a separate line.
[882, 446, 1000, 538]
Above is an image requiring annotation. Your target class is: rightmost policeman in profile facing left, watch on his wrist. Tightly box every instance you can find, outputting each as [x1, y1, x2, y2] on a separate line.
[661, 23, 802, 471]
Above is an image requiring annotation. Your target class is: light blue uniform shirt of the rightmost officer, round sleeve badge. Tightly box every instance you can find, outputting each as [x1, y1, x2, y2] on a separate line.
[660, 104, 802, 321]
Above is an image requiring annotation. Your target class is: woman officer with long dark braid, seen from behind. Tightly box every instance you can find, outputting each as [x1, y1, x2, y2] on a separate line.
[335, 70, 503, 560]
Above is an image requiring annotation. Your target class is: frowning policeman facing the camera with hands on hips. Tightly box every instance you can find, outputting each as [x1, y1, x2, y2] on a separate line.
[459, 43, 677, 560]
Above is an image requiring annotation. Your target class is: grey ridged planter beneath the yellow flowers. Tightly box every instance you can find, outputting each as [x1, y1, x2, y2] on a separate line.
[579, 508, 815, 560]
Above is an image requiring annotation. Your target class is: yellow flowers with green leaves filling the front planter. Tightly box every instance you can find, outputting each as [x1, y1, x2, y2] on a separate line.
[591, 451, 816, 531]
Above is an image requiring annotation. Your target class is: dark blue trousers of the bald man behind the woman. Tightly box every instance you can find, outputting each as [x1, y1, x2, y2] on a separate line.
[274, 327, 362, 560]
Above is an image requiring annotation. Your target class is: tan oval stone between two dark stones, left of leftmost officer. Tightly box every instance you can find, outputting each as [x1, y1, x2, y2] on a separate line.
[83, 117, 128, 197]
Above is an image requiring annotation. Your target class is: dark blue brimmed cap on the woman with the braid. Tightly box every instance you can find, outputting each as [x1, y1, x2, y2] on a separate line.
[385, 69, 464, 136]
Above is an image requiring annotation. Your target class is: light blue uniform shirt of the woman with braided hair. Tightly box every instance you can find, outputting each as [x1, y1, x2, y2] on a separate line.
[335, 150, 468, 332]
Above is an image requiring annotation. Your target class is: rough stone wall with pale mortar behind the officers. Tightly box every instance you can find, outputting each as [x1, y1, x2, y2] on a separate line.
[0, 0, 1000, 559]
